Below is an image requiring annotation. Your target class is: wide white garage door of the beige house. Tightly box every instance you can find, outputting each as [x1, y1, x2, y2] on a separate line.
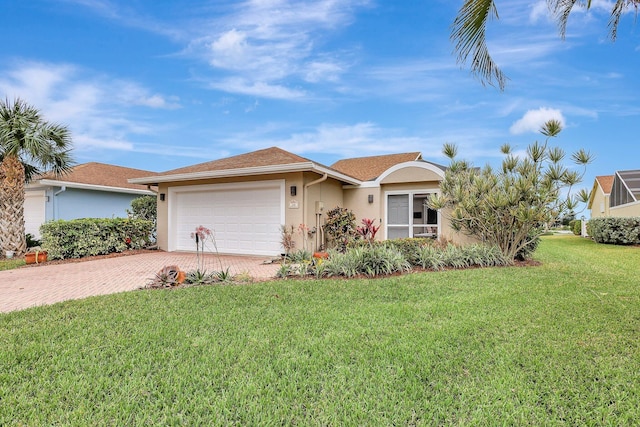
[169, 181, 284, 255]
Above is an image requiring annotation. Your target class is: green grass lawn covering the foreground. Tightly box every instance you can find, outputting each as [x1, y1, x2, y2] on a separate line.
[0, 236, 640, 426]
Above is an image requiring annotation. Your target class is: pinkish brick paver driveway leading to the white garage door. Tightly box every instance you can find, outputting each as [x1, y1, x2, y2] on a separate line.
[0, 251, 278, 312]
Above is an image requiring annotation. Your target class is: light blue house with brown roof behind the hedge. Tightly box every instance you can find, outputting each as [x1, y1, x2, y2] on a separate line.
[24, 162, 156, 238]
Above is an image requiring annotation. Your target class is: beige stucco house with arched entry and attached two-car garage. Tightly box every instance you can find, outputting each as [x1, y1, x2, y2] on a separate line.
[129, 147, 465, 255]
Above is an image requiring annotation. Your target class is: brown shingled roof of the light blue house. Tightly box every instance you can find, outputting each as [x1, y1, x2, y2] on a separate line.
[33, 162, 155, 190]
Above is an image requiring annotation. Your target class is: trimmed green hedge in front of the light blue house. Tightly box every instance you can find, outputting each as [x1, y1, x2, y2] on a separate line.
[40, 218, 154, 259]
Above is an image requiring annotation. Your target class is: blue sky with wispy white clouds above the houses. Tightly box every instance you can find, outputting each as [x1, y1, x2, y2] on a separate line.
[0, 0, 640, 202]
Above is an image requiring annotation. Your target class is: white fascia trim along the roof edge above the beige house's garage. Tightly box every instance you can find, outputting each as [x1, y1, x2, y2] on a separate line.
[129, 162, 360, 185]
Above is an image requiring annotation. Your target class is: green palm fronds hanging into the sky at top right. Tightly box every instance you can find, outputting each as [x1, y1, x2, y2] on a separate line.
[451, 0, 640, 90]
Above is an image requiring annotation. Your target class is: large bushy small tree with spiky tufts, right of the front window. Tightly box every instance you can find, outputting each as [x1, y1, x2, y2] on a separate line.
[428, 120, 592, 259]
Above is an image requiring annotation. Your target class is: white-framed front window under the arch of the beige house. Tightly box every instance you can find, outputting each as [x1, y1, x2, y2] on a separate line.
[387, 192, 440, 239]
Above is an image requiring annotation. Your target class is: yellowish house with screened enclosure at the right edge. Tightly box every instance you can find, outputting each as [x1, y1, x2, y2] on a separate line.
[588, 170, 640, 218]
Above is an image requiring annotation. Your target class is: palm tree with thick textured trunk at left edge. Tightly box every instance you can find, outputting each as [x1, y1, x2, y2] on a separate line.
[0, 99, 72, 254]
